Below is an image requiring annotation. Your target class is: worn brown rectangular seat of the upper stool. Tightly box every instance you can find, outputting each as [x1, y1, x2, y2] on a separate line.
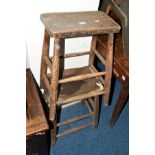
[40, 11, 121, 38]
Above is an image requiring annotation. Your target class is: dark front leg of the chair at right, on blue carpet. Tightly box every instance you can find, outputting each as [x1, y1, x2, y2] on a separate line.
[110, 86, 129, 127]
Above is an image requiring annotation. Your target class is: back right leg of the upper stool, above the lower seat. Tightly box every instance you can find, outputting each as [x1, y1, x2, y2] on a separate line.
[89, 36, 97, 65]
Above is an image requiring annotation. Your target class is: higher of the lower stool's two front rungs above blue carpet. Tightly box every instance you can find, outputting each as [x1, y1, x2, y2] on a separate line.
[57, 113, 94, 127]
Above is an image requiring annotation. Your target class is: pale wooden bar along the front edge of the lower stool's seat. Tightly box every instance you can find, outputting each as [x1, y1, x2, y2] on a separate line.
[57, 90, 105, 106]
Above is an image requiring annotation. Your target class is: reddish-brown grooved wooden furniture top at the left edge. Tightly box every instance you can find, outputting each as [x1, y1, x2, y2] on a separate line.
[26, 69, 48, 137]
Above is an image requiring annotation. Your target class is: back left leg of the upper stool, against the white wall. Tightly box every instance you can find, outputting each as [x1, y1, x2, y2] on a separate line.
[40, 29, 50, 89]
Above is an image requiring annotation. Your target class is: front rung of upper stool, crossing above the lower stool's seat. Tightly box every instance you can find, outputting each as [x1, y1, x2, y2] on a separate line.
[58, 72, 106, 84]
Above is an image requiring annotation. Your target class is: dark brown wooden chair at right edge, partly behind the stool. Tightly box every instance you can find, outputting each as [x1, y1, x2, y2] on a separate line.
[97, 0, 129, 126]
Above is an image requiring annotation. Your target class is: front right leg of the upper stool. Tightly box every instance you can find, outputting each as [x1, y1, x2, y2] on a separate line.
[104, 33, 114, 106]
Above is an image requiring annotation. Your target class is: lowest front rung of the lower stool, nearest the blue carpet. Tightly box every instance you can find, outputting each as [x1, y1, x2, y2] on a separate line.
[56, 122, 94, 137]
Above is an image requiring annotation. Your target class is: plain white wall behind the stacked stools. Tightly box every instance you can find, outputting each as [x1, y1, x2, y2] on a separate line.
[26, 0, 99, 83]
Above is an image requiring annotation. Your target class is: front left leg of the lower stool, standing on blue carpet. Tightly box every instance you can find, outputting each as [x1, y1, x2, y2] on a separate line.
[51, 116, 57, 145]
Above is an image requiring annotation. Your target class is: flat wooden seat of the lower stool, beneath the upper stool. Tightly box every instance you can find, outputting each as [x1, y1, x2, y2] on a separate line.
[43, 66, 105, 105]
